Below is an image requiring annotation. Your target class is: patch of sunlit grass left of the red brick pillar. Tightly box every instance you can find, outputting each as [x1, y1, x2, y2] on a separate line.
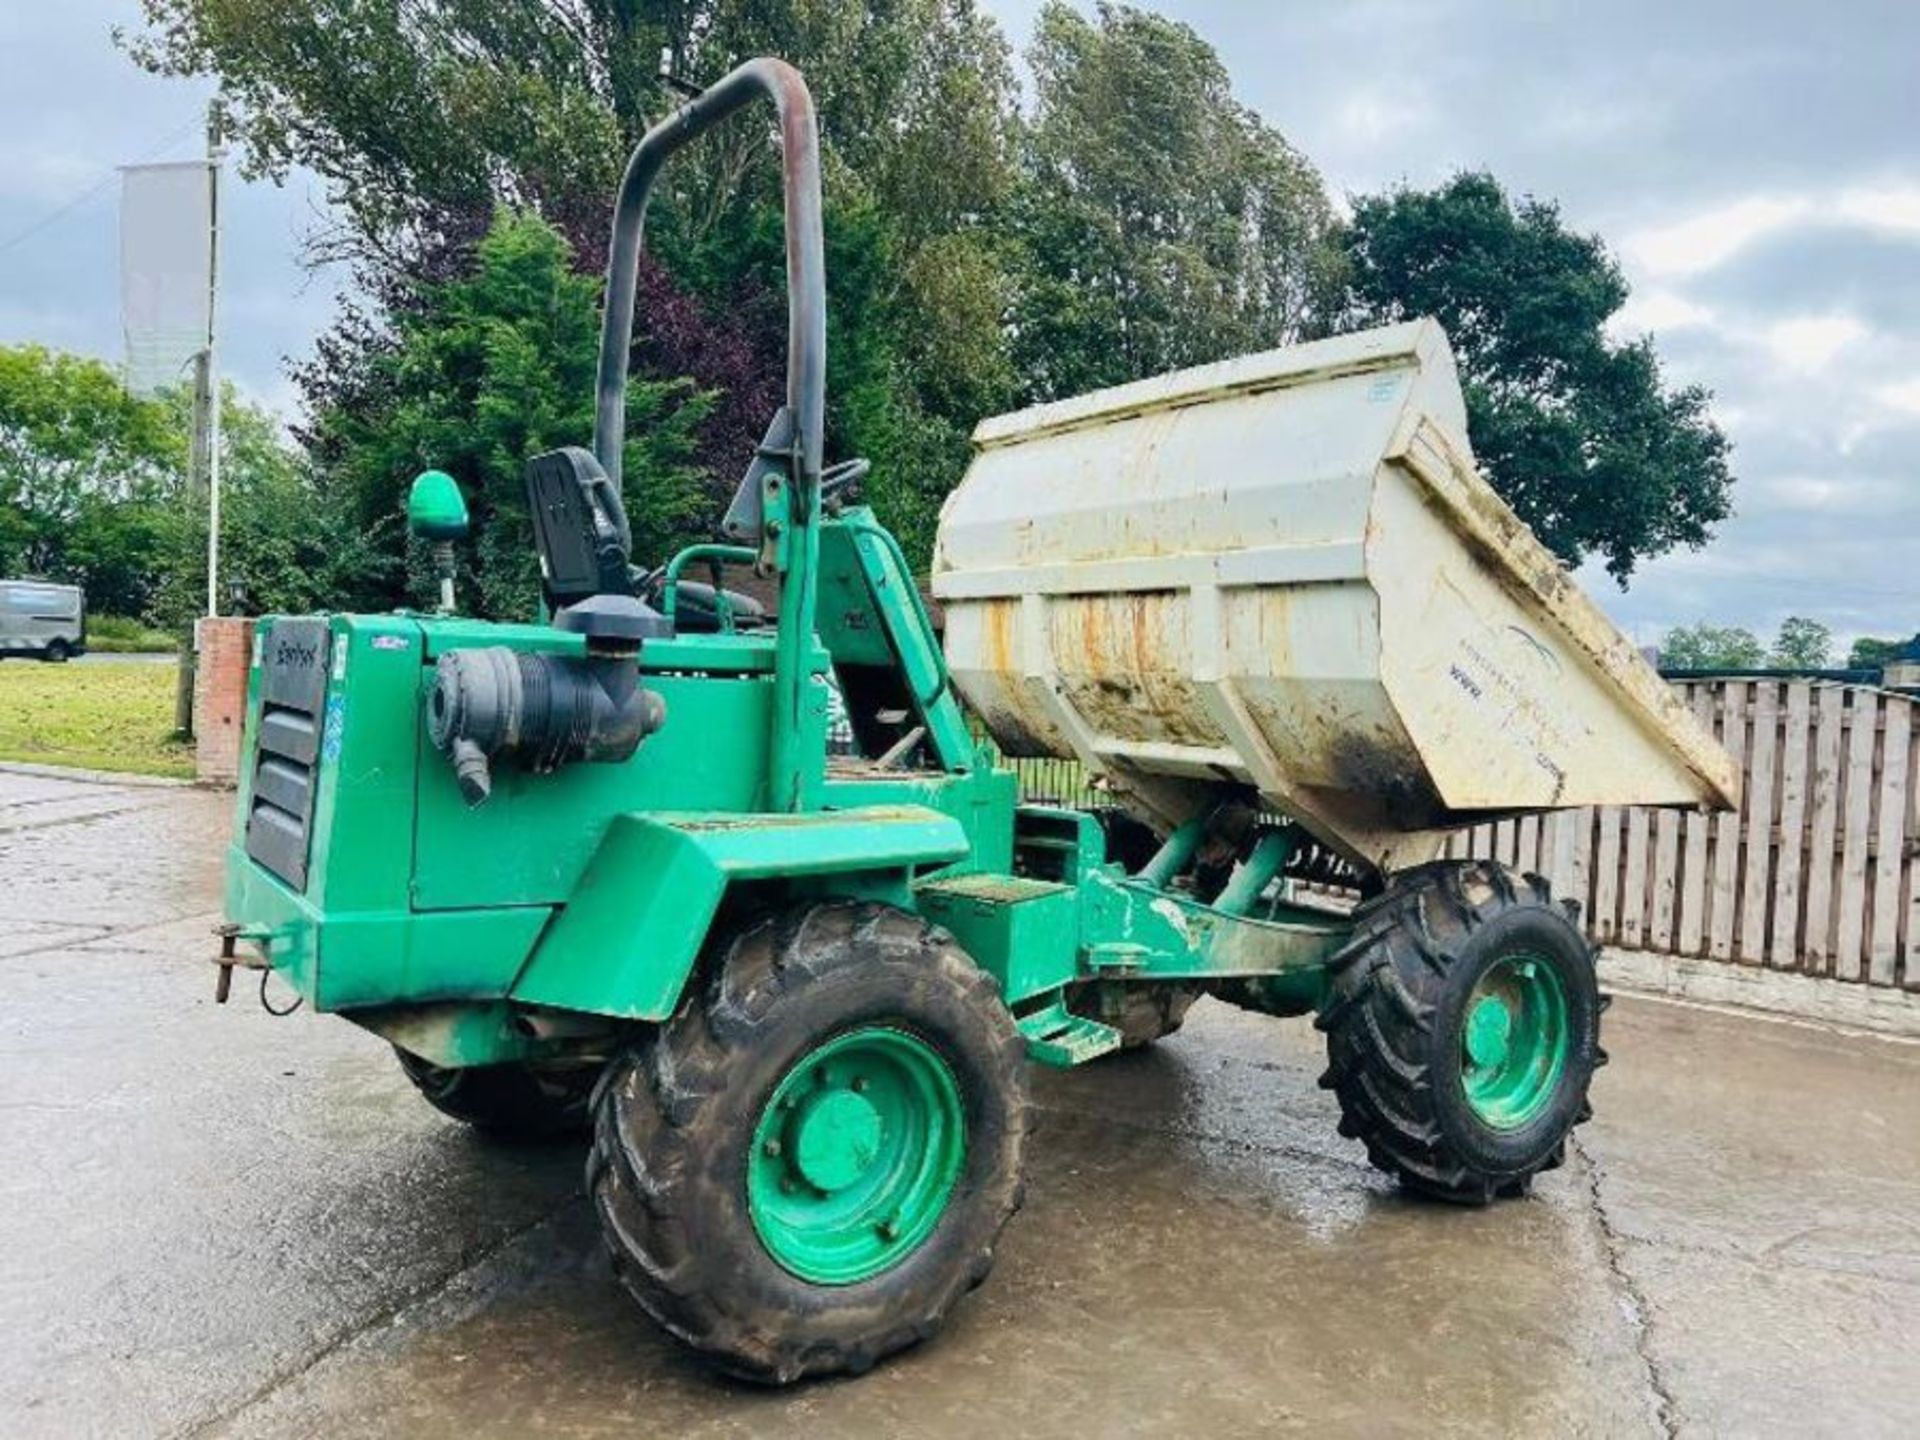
[0, 660, 194, 780]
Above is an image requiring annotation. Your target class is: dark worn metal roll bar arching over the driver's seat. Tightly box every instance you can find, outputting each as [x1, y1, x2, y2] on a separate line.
[593, 60, 828, 511]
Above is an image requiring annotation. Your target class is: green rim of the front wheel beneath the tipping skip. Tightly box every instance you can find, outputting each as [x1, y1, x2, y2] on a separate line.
[1459, 954, 1571, 1131]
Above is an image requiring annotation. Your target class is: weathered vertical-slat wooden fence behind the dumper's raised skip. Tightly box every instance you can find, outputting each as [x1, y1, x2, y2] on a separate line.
[1016, 680, 1920, 989]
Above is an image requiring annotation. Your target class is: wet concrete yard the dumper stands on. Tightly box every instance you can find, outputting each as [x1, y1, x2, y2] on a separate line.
[0, 774, 1920, 1440]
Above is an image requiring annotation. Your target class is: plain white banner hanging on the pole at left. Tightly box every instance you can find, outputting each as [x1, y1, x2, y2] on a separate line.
[121, 159, 213, 396]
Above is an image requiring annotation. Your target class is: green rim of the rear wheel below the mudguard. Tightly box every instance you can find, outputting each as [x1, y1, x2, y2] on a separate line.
[747, 1025, 966, 1284]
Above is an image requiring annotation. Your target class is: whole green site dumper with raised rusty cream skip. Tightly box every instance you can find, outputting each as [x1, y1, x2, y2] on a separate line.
[210, 60, 1732, 1382]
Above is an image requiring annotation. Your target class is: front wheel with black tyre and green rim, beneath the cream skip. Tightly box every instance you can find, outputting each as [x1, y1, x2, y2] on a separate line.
[1315, 860, 1607, 1204]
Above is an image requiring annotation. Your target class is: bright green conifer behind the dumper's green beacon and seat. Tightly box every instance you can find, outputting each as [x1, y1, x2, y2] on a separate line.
[311, 211, 710, 618]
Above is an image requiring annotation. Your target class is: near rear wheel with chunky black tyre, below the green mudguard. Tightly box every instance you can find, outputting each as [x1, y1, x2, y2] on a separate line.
[588, 902, 1027, 1384]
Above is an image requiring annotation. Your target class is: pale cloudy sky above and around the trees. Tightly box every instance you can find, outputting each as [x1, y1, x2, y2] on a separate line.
[0, 0, 1920, 641]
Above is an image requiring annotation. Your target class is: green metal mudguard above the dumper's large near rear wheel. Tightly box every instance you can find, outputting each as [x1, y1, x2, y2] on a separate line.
[513, 804, 968, 1020]
